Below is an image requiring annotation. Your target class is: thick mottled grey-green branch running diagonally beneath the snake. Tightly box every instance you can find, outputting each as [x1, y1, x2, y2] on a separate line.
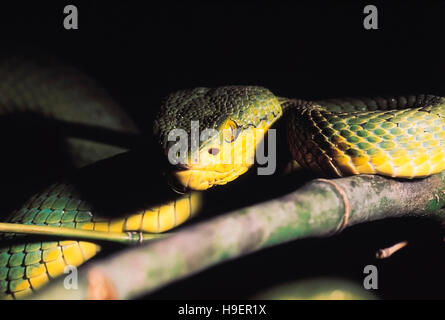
[32, 173, 445, 299]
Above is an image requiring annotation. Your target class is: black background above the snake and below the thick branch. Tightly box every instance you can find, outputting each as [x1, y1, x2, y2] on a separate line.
[0, 1, 445, 298]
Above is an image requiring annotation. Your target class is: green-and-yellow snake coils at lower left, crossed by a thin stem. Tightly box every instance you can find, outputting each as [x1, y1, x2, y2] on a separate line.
[0, 184, 201, 298]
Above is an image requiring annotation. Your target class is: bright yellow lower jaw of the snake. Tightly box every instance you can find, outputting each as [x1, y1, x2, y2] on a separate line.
[172, 165, 249, 190]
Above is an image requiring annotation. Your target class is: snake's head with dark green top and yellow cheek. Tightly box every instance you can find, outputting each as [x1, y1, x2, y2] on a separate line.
[154, 86, 282, 191]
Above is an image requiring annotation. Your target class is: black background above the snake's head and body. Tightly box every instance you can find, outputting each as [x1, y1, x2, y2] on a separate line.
[0, 1, 445, 131]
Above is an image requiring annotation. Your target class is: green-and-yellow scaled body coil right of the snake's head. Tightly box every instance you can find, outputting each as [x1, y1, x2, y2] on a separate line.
[288, 99, 445, 179]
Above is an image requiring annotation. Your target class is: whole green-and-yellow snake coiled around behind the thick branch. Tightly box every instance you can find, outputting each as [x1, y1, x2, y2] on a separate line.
[0, 60, 445, 299]
